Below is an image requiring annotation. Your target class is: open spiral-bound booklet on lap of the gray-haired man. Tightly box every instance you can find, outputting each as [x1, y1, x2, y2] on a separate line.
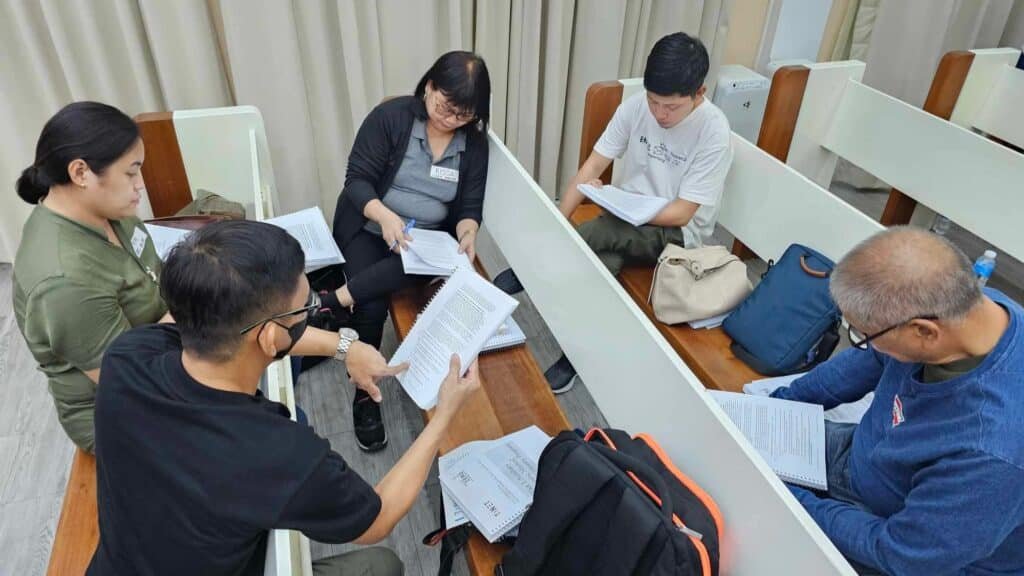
[708, 390, 828, 490]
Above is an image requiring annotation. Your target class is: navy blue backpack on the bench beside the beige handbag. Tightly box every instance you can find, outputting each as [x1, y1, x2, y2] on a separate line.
[722, 244, 840, 376]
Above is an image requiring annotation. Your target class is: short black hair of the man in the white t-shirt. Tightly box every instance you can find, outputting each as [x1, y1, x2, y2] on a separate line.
[643, 32, 711, 96]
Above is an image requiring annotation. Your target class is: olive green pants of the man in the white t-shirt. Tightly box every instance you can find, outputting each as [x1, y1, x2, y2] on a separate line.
[577, 213, 683, 275]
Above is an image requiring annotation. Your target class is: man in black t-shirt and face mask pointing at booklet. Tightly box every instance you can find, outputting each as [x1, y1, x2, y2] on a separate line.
[88, 217, 479, 576]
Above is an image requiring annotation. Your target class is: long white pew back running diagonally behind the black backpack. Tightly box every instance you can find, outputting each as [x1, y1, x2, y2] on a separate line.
[484, 133, 854, 576]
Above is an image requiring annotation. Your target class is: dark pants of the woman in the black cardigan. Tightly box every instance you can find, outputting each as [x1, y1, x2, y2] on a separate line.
[343, 230, 427, 348]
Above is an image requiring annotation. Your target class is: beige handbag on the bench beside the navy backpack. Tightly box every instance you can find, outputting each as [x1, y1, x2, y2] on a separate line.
[647, 244, 753, 324]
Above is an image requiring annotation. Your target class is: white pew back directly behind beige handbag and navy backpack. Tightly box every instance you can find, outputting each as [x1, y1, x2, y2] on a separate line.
[718, 134, 885, 261]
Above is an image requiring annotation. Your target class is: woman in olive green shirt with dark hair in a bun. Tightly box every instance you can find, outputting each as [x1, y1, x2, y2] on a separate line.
[13, 101, 161, 452]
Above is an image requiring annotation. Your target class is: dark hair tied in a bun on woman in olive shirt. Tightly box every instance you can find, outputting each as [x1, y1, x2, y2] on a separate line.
[15, 101, 139, 204]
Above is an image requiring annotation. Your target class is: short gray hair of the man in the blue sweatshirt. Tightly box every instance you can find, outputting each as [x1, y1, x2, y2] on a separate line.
[829, 227, 981, 331]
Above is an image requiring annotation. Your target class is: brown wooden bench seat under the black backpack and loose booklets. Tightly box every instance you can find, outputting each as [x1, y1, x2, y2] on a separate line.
[391, 269, 570, 576]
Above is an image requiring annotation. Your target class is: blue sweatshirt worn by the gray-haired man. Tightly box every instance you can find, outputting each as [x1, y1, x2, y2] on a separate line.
[773, 289, 1024, 576]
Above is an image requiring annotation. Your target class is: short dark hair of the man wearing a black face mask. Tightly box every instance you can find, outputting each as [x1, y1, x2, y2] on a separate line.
[160, 220, 305, 361]
